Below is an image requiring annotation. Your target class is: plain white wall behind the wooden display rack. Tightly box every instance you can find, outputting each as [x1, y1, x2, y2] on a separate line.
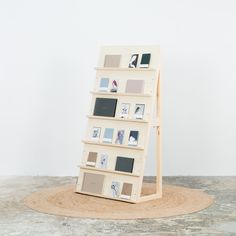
[0, 0, 236, 175]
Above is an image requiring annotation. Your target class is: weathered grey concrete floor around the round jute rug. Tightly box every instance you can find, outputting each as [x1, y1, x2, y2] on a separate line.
[0, 177, 236, 236]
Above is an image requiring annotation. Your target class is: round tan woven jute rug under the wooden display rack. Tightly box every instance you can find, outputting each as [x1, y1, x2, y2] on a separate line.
[24, 183, 214, 219]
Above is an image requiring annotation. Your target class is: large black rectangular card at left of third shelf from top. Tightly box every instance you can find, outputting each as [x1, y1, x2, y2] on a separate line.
[93, 98, 117, 117]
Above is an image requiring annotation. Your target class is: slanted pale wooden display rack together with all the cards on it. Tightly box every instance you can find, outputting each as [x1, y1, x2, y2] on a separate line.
[76, 46, 162, 203]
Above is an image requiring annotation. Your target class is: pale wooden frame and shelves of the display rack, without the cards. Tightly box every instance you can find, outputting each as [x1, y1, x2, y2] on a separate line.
[76, 46, 162, 203]
